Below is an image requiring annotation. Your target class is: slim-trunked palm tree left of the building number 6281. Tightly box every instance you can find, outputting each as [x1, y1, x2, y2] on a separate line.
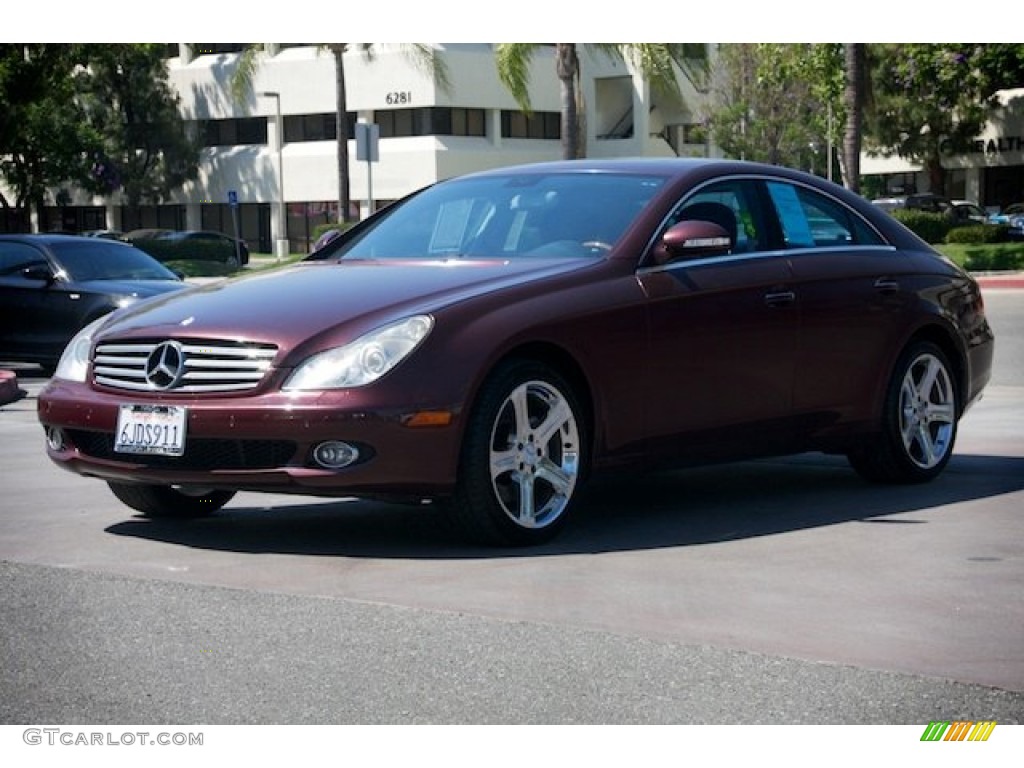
[230, 43, 450, 223]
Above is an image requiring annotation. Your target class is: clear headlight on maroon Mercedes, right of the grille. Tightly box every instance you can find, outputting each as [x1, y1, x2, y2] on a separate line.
[285, 314, 434, 390]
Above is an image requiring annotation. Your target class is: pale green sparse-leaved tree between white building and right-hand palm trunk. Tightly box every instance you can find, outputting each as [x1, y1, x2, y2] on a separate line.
[706, 43, 845, 177]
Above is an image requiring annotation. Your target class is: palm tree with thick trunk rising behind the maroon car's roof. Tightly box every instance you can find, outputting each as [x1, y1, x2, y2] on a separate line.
[496, 43, 704, 160]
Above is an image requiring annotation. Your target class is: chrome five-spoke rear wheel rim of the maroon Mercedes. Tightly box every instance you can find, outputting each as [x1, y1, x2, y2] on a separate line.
[899, 353, 956, 469]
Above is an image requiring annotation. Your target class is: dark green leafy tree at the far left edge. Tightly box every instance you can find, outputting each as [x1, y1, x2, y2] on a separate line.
[0, 43, 99, 227]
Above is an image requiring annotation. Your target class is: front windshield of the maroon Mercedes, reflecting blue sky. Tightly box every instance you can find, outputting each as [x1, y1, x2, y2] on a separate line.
[333, 173, 664, 259]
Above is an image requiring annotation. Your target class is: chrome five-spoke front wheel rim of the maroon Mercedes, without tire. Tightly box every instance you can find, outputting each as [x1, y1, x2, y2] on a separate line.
[489, 381, 580, 528]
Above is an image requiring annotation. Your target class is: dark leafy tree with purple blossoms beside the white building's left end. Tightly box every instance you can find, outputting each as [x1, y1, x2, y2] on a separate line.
[76, 44, 200, 207]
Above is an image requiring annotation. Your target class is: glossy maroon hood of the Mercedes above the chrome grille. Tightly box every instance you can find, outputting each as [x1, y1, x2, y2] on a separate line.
[100, 259, 601, 347]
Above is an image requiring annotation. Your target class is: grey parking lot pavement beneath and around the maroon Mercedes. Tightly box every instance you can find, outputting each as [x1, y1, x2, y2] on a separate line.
[0, 290, 1024, 724]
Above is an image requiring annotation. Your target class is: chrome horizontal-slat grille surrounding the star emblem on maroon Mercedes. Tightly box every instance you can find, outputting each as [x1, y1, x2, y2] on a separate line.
[92, 339, 278, 392]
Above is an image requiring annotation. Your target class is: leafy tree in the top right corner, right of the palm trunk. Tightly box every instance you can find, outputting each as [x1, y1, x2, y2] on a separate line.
[868, 43, 1024, 193]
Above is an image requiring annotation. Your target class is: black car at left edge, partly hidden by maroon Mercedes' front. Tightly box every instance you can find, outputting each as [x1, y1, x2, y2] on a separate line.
[0, 234, 185, 368]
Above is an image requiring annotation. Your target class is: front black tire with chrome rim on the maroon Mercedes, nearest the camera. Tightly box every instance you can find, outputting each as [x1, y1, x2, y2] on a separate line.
[447, 360, 587, 547]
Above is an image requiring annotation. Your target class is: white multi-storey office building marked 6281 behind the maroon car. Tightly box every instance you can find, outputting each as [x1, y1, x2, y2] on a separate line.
[29, 43, 709, 253]
